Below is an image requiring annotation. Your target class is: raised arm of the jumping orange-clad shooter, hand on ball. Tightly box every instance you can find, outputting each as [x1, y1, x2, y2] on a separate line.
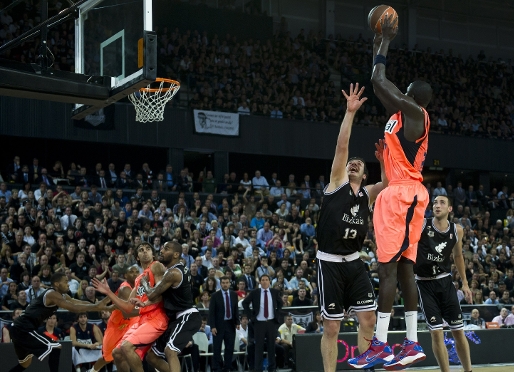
[371, 16, 425, 141]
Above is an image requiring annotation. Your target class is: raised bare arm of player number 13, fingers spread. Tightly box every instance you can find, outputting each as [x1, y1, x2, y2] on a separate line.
[327, 83, 367, 192]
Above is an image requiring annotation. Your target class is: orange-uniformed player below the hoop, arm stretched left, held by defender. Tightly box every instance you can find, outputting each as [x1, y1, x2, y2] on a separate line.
[92, 242, 168, 372]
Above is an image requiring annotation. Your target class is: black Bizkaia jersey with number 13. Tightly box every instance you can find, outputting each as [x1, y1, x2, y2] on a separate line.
[316, 182, 370, 255]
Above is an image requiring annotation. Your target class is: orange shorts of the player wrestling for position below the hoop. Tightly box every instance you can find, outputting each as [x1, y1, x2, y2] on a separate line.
[116, 308, 168, 360]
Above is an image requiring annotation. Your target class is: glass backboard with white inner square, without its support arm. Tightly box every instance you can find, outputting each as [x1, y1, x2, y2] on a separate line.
[74, 0, 157, 119]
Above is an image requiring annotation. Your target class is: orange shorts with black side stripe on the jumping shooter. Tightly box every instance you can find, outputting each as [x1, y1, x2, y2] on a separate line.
[373, 180, 429, 263]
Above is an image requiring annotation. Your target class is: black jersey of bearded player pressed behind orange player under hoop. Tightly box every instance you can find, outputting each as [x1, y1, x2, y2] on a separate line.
[162, 263, 194, 318]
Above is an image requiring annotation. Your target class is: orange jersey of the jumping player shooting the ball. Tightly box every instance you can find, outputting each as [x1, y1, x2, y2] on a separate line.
[384, 108, 430, 182]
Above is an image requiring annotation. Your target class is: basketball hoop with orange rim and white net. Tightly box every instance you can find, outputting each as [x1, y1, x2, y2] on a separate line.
[129, 78, 180, 123]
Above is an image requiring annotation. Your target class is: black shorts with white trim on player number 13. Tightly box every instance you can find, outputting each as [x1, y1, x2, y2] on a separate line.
[317, 259, 377, 320]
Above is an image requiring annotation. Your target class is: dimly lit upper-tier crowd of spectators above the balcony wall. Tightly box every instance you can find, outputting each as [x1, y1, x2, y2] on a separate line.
[0, 0, 514, 140]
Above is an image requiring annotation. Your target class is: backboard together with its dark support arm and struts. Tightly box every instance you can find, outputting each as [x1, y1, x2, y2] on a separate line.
[0, 0, 157, 119]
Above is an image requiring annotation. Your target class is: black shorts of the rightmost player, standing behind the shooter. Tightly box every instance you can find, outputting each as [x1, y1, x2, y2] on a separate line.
[416, 275, 464, 331]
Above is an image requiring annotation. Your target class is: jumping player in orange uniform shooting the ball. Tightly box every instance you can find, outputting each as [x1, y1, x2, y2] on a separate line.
[349, 16, 432, 370]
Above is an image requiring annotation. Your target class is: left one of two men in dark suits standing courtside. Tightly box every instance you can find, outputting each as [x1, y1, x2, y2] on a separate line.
[209, 276, 239, 372]
